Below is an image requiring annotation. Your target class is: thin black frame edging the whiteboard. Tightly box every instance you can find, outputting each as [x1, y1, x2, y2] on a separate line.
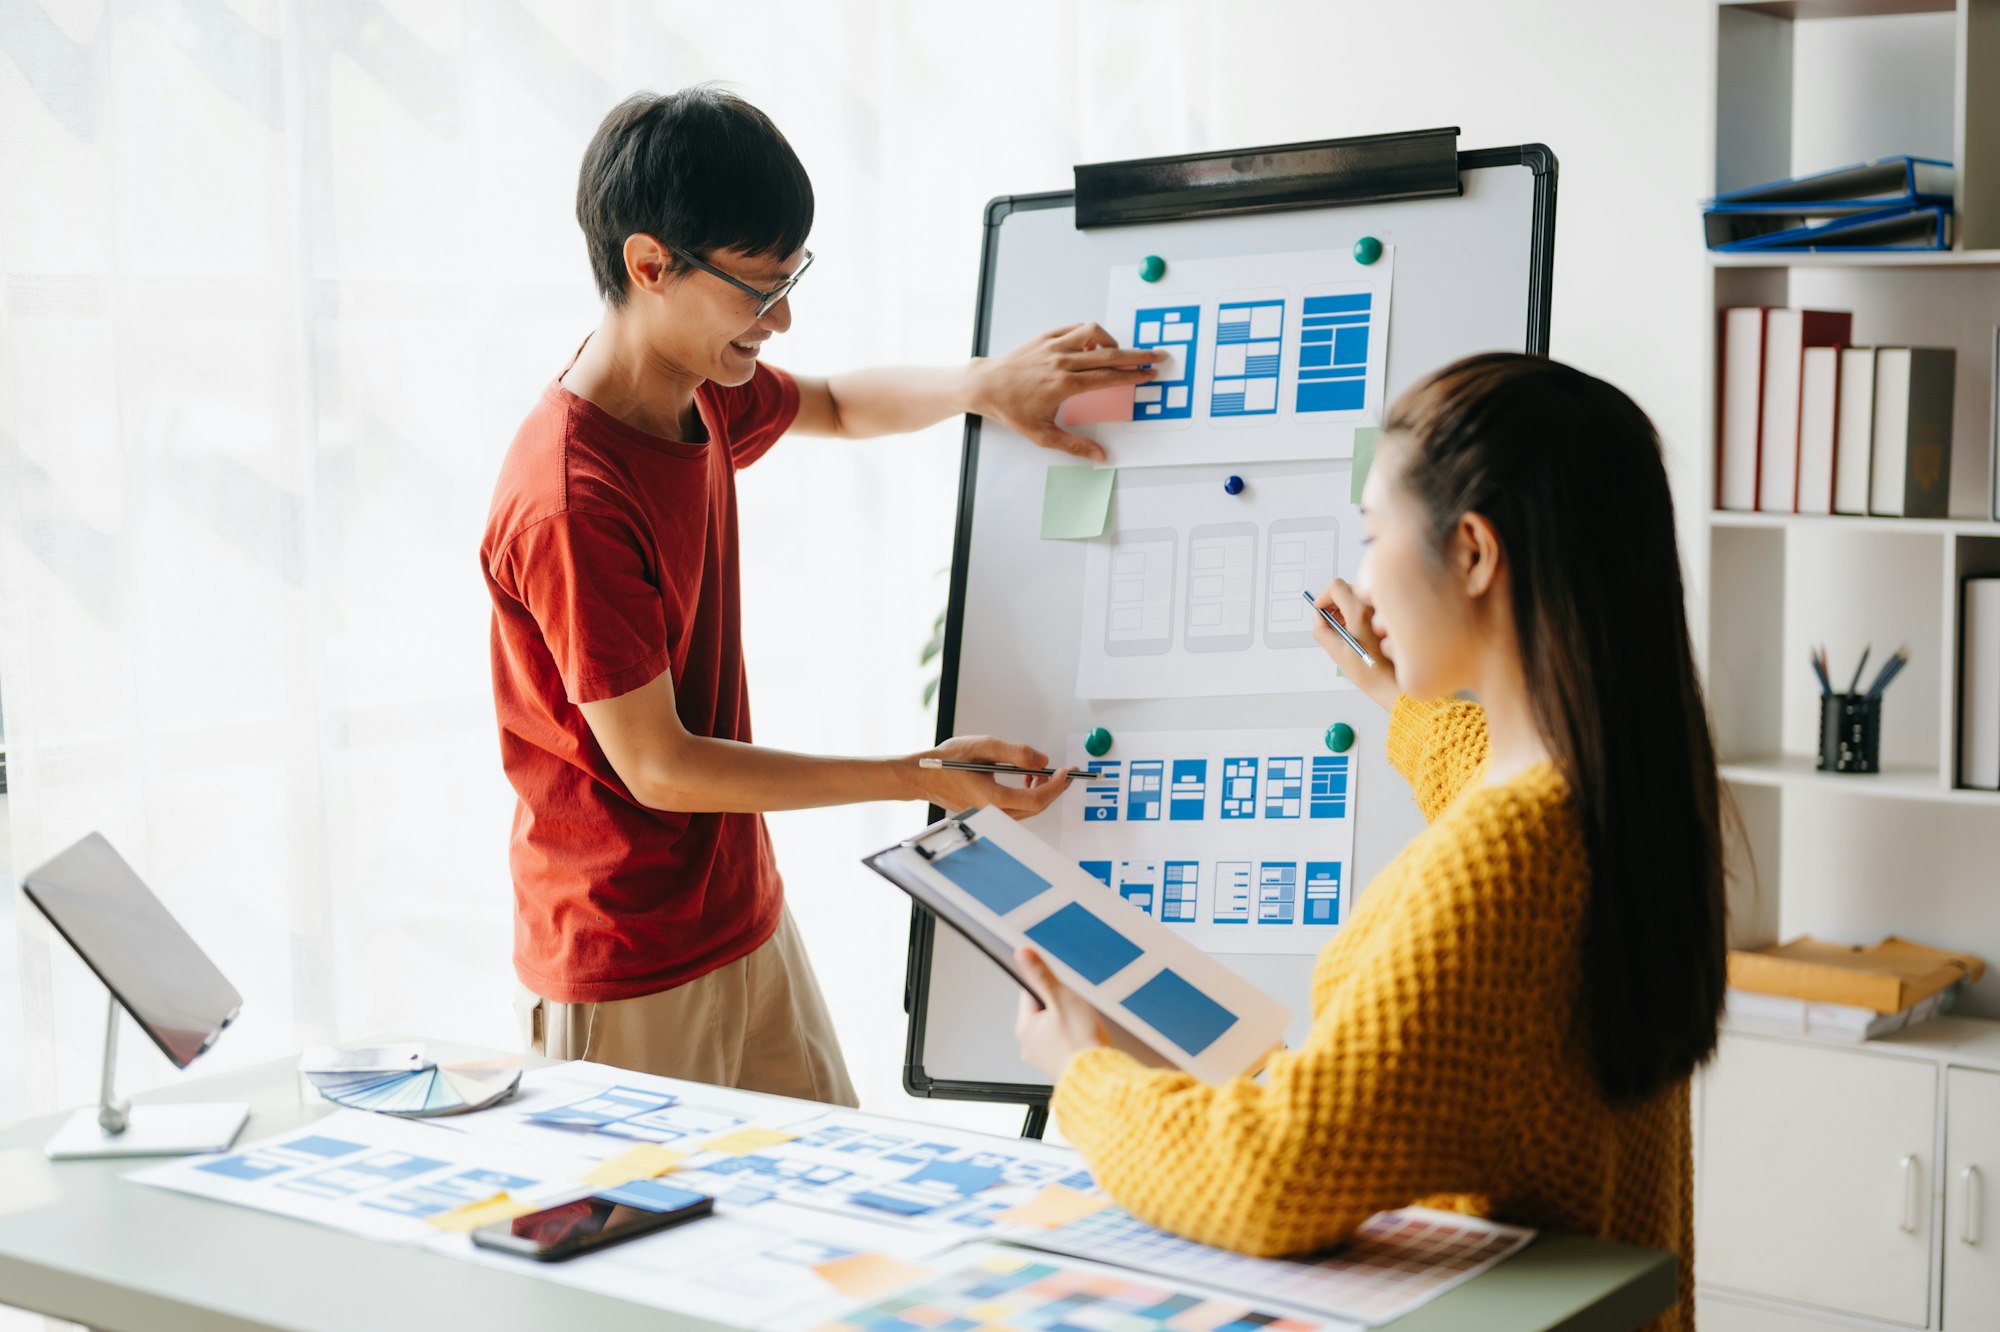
[902, 144, 1558, 1104]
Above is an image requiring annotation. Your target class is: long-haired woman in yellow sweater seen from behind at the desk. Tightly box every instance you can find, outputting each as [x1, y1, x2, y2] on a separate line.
[1018, 354, 1724, 1328]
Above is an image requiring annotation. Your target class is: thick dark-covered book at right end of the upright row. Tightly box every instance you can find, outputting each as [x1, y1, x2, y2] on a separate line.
[1868, 346, 1958, 518]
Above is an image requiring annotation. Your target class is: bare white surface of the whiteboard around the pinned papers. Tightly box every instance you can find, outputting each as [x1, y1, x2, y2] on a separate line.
[904, 146, 1556, 1104]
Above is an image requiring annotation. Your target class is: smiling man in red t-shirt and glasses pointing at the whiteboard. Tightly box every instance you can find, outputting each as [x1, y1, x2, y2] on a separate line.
[480, 86, 1152, 1104]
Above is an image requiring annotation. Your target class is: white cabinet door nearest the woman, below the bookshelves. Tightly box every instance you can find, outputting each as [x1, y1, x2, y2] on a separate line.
[1694, 1034, 1938, 1328]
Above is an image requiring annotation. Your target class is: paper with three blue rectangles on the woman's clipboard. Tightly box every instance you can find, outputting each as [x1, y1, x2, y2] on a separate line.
[866, 808, 1292, 1082]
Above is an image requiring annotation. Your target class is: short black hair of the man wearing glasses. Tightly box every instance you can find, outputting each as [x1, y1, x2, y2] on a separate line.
[576, 84, 812, 306]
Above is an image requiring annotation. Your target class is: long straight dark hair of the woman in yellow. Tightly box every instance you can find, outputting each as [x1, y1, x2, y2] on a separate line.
[1384, 354, 1726, 1102]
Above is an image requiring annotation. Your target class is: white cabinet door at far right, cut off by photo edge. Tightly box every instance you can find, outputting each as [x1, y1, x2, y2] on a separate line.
[1944, 1068, 2000, 1332]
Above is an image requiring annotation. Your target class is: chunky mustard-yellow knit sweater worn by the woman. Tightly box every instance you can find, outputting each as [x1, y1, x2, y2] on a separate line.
[1054, 698, 1694, 1330]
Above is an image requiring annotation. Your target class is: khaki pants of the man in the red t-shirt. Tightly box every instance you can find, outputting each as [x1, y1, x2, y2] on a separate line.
[514, 908, 860, 1106]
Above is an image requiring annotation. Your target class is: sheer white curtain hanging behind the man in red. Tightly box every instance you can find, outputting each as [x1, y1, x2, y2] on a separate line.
[0, 0, 1198, 1120]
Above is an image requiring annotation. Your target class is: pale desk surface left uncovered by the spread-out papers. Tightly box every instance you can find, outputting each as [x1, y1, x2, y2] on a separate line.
[0, 1036, 1674, 1332]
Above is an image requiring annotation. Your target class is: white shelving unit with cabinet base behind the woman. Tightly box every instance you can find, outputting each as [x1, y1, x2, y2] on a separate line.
[1684, 0, 2000, 1332]
